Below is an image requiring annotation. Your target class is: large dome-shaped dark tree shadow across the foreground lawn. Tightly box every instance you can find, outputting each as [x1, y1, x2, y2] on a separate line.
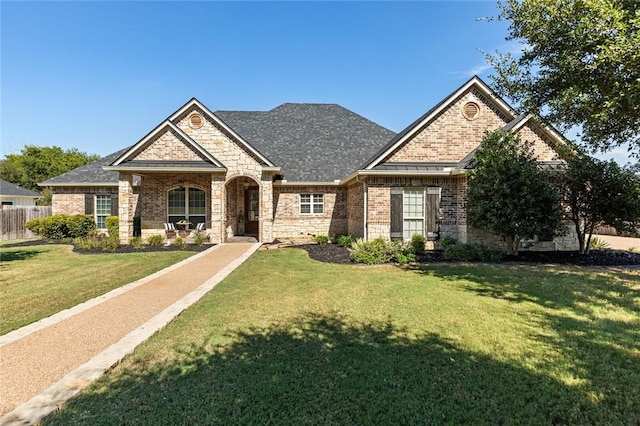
[50, 314, 620, 425]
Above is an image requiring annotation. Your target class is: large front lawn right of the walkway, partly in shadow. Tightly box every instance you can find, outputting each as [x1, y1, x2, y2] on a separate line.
[40, 249, 640, 425]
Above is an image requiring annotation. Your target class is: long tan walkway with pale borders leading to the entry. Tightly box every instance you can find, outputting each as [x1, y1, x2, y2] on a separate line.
[0, 243, 260, 425]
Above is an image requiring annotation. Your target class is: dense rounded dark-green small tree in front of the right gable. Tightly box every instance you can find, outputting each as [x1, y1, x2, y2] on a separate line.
[467, 130, 563, 254]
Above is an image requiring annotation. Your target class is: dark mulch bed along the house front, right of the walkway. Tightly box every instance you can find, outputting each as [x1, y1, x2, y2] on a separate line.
[294, 244, 640, 266]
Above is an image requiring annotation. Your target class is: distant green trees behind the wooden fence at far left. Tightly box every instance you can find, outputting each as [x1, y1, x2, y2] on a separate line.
[0, 145, 99, 192]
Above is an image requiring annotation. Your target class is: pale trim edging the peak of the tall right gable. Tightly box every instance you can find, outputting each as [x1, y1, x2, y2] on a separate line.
[363, 76, 517, 170]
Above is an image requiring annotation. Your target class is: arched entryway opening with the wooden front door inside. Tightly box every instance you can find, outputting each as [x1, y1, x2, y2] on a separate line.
[225, 176, 261, 241]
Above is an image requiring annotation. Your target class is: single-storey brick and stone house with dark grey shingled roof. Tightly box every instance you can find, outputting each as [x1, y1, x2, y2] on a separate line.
[41, 77, 575, 249]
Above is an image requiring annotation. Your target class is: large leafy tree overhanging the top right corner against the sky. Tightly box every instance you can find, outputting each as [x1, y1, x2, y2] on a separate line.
[487, 0, 640, 156]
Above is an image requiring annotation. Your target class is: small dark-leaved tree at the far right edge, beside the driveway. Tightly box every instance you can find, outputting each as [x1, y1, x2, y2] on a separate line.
[560, 154, 640, 254]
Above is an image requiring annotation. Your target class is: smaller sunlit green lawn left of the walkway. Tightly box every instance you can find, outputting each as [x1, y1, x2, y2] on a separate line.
[0, 244, 200, 335]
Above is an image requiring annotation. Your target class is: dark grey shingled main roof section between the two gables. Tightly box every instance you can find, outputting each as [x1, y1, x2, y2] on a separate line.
[215, 103, 395, 182]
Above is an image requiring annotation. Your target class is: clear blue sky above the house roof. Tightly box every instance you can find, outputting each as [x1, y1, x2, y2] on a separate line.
[0, 1, 626, 163]
